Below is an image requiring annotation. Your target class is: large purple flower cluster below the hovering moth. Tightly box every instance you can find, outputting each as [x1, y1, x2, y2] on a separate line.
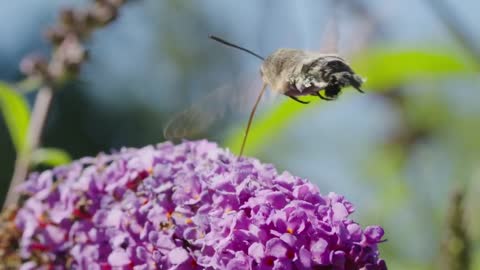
[15, 141, 386, 270]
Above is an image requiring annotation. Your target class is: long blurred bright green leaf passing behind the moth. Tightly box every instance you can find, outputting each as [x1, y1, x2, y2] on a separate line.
[224, 48, 475, 155]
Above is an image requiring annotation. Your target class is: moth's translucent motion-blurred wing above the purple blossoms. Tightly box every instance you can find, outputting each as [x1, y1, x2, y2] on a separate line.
[164, 75, 274, 140]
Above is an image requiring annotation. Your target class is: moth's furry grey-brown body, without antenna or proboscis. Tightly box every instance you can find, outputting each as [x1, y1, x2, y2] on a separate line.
[260, 49, 363, 99]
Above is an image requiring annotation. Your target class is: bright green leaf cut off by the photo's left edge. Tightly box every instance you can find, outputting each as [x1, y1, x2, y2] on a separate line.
[0, 82, 30, 152]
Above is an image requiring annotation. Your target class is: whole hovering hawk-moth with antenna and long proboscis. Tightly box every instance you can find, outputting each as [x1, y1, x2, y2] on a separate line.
[164, 36, 364, 156]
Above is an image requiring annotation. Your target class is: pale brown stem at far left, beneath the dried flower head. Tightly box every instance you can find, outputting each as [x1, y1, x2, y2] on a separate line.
[3, 86, 53, 209]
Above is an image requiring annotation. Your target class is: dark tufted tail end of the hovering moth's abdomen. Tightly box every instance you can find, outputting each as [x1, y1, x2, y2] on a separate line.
[320, 56, 365, 93]
